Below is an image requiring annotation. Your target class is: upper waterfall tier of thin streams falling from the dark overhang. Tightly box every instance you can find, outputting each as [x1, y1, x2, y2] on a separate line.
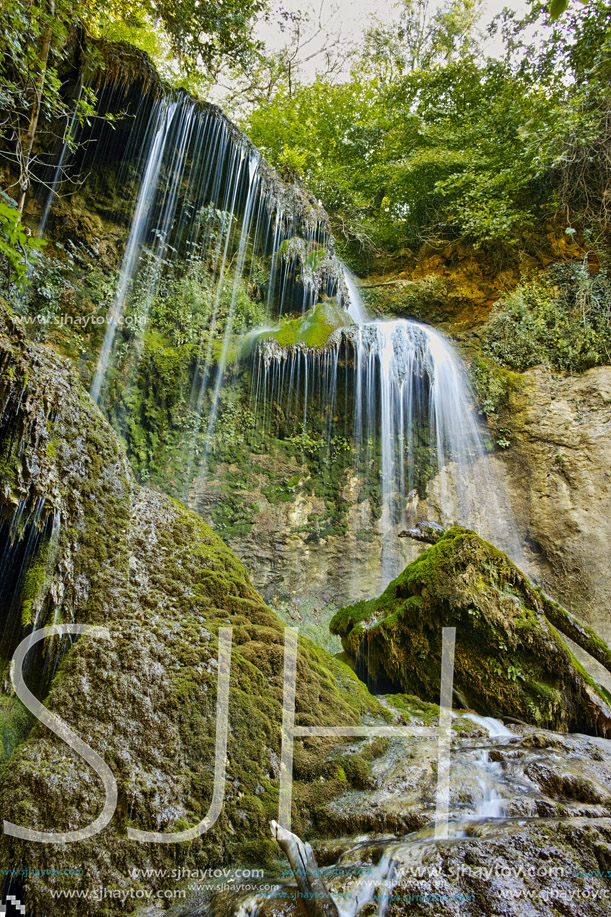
[56, 86, 350, 426]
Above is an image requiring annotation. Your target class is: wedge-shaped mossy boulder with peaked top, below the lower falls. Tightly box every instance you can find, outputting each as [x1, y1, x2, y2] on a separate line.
[331, 527, 611, 736]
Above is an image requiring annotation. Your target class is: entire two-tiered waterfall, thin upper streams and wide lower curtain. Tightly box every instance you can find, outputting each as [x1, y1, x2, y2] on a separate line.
[33, 77, 515, 585]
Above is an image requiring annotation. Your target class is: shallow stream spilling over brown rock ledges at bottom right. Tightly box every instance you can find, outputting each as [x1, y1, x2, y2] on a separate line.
[154, 713, 611, 917]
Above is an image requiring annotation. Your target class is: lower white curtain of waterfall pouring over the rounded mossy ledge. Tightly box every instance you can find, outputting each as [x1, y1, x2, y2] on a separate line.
[253, 273, 518, 586]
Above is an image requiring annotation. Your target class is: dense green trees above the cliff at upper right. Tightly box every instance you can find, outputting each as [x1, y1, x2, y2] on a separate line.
[247, 0, 611, 268]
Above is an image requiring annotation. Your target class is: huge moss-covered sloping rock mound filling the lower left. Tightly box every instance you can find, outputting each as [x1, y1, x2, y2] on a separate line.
[0, 309, 387, 917]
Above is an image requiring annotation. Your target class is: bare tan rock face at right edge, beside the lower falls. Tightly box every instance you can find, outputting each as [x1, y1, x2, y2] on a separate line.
[497, 366, 611, 640]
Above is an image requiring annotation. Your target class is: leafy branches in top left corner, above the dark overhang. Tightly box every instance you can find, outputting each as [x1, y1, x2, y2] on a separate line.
[0, 0, 266, 285]
